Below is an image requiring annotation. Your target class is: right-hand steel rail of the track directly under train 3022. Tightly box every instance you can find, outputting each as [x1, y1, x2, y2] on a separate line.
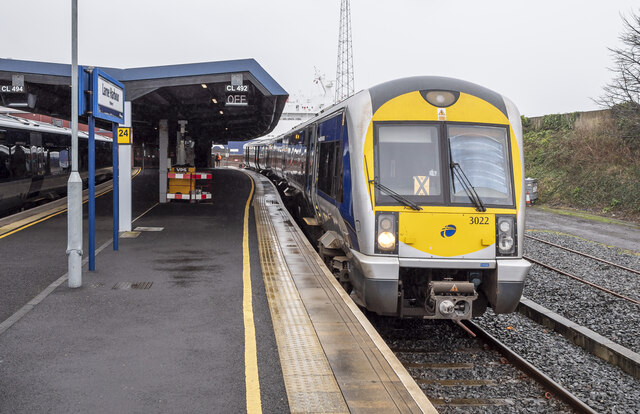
[463, 320, 597, 414]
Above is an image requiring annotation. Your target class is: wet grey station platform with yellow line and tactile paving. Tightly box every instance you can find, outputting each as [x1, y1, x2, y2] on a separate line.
[0, 169, 435, 413]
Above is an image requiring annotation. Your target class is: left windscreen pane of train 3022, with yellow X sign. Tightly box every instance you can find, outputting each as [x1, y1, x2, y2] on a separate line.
[371, 124, 444, 205]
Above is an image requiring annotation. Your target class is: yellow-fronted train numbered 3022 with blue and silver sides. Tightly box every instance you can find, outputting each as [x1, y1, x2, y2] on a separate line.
[244, 76, 531, 323]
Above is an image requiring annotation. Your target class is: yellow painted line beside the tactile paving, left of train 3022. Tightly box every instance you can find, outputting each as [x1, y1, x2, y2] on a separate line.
[242, 177, 262, 414]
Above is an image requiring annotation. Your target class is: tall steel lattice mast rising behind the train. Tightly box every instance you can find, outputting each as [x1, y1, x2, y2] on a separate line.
[336, 0, 354, 102]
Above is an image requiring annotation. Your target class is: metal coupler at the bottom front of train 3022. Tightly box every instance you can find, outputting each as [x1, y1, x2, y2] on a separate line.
[425, 281, 478, 320]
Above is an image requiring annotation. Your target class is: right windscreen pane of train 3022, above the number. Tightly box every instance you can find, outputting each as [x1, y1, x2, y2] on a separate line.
[447, 125, 513, 205]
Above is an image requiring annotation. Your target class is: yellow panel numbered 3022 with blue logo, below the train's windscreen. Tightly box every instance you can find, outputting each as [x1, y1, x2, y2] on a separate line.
[399, 212, 496, 257]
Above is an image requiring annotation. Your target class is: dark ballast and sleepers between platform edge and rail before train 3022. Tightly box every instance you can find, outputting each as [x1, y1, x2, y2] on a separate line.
[372, 317, 570, 413]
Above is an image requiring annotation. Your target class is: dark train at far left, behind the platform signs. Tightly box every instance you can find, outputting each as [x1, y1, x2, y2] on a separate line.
[0, 114, 113, 217]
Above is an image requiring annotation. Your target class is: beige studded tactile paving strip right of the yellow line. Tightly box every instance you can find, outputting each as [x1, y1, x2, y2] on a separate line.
[254, 187, 349, 413]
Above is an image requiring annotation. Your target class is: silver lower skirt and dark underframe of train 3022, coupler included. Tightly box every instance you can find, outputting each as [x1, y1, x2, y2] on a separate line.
[319, 241, 530, 320]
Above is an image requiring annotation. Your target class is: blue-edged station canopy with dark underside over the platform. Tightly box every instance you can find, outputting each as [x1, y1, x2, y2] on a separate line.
[0, 59, 288, 146]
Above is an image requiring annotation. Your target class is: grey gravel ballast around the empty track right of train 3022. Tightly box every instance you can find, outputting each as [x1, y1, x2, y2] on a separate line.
[523, 233, 640, 352]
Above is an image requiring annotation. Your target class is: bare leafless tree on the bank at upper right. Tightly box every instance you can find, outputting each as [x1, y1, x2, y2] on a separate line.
[597, 13, 640, 146]
